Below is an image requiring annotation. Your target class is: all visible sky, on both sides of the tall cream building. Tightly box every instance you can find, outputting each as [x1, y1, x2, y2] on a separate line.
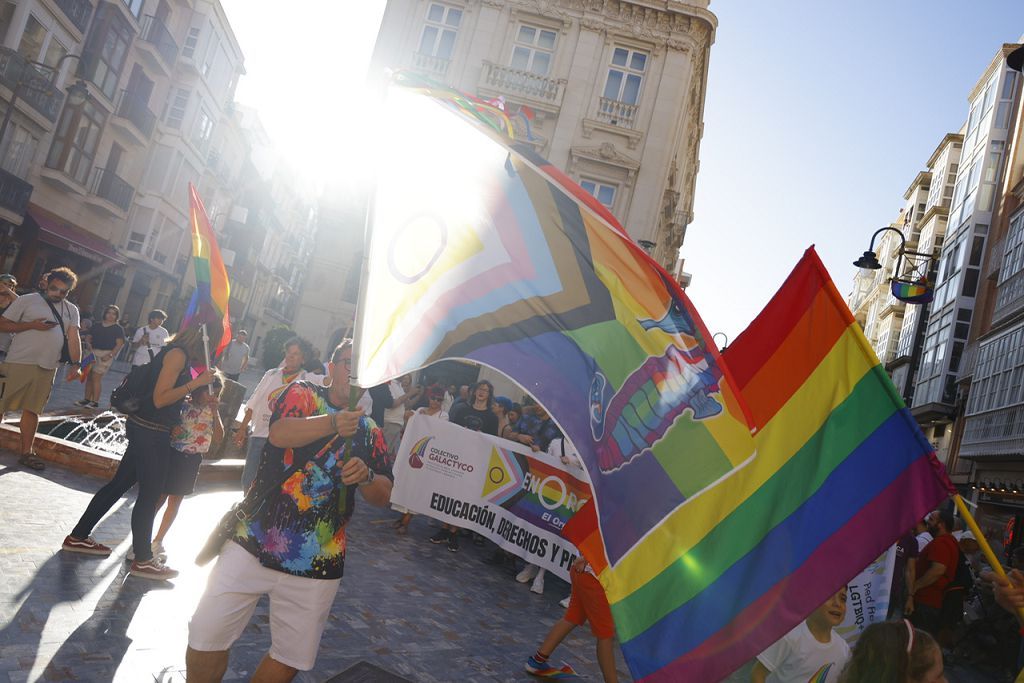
[222, 0, 1024, 340]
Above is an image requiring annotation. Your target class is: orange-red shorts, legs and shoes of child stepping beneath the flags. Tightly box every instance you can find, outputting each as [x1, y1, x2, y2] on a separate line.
[526, 557, 618, 683]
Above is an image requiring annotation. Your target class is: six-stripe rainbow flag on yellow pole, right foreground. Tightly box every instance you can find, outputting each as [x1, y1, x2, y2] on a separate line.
[564, 249, 954, 681]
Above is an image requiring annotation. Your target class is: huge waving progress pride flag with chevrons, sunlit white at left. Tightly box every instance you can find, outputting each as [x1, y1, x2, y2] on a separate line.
[356, 72, 755, 563]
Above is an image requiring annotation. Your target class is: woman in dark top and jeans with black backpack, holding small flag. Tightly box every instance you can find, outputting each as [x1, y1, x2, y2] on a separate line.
[62, 322, 220, 581]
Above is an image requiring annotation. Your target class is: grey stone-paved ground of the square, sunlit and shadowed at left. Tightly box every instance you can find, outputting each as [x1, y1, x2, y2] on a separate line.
[0, 453, 631, 683]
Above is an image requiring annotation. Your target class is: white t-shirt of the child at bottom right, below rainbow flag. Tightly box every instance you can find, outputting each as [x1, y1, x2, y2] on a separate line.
[758, 622, 850, 683]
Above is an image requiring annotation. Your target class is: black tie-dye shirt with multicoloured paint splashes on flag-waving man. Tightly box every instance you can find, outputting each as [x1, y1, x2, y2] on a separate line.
[234, 382, 387, 579]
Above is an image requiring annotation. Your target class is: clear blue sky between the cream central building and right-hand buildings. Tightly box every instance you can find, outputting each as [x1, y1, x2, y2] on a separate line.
[683, 0, 1024, 341]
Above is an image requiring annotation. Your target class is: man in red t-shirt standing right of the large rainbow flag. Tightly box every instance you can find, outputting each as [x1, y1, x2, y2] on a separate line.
[908, 510, 959, 637]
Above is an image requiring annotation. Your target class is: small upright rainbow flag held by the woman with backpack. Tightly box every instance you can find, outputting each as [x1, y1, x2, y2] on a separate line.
[181, 182, 231, 357]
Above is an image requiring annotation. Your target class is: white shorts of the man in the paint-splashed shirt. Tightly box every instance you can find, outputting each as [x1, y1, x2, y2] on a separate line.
[188, 541, 341, 671]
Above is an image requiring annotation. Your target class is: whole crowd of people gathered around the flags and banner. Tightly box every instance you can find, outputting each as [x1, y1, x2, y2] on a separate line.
[6, 268, 1024, 683]
